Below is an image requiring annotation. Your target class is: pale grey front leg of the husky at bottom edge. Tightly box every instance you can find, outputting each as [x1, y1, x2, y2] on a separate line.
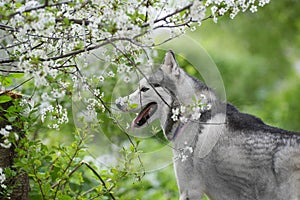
[174, 159, 204, 200]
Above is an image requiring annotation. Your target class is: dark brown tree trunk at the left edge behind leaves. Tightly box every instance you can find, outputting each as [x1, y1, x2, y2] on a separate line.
[0, 91, 30, 200]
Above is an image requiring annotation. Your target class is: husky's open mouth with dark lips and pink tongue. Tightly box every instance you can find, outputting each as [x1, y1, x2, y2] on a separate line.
[132, 102, 157, 127]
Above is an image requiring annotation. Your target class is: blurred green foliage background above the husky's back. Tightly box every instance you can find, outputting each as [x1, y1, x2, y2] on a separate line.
[189, 0, 300, 131]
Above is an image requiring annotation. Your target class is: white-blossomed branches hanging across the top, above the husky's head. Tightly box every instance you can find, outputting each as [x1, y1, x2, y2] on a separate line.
[0, 0, 269, 128]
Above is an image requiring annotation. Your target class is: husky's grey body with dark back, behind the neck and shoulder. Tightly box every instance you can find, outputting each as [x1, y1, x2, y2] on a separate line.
[195, 104, 300, 200]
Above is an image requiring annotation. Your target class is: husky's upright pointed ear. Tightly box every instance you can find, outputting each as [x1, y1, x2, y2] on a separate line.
[161, 50, 180, 76]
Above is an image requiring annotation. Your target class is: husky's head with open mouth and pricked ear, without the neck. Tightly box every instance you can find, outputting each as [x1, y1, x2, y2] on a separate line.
[116, 51, 181, 128]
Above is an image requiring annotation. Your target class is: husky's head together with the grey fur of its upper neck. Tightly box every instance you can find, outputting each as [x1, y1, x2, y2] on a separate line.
[116, 51, 214, 139]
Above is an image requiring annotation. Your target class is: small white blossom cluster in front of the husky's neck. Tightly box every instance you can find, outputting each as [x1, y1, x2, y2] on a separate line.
[171, 94, 211, 123]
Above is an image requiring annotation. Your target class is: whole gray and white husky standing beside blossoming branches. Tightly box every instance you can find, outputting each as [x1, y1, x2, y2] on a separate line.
[117, 51, 300, 200]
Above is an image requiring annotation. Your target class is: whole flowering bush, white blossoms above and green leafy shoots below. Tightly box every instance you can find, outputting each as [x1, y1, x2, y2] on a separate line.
[0, 0, 269, 199]
